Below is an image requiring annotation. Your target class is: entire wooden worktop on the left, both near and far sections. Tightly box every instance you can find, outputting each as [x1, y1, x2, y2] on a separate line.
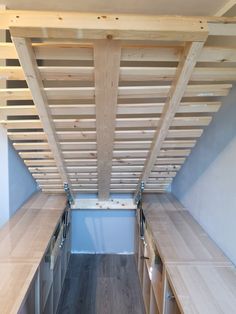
[0, 192, 66, 314]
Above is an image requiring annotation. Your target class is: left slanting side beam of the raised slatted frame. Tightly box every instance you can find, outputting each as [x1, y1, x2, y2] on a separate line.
[12, 37, 70, 194]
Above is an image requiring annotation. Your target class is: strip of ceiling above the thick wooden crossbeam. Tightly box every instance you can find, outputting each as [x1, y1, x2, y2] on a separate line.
[0, 0, 228, 15]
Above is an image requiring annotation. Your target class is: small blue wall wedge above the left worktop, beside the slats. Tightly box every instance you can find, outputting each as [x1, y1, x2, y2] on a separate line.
[8, 141, 37, 216]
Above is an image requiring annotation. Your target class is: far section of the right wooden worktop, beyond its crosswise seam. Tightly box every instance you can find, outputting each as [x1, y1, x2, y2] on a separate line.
[143, 194, 231, 265]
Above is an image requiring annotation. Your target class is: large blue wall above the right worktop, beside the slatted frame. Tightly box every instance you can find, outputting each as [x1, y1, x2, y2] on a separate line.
[172, 87, 236, 264]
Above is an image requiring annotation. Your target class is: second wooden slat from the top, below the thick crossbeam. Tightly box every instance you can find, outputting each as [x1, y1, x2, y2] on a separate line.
[0, 66, 236, 82]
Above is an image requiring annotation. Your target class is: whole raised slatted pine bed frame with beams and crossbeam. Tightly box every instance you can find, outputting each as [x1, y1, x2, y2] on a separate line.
[0, 10, 236, 200]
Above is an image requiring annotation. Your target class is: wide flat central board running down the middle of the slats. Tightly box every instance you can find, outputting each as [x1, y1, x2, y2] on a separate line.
[94, 39, 121, 200]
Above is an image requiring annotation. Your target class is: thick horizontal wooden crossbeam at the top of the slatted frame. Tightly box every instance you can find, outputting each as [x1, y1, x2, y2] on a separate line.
[0, 10, 208, 41]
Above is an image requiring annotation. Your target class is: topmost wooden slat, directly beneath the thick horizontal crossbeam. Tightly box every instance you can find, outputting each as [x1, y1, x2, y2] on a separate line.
[0, 42, 236, 64]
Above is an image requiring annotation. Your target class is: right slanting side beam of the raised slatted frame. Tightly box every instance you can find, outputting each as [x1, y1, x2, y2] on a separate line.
[136, 42, 204, 193]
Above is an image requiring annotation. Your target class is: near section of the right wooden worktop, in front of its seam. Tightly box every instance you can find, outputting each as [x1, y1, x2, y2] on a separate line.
[166, 264, 236, 314]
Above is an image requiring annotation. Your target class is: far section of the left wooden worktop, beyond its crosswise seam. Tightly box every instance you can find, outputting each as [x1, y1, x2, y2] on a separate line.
[0, 193, 66, 266]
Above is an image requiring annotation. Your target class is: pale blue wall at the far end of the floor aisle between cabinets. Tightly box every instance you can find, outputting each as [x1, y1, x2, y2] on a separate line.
[72, 210, 135, 254]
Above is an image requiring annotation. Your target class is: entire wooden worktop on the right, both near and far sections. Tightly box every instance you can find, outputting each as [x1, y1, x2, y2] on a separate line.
[142, 194, 236, 314]
